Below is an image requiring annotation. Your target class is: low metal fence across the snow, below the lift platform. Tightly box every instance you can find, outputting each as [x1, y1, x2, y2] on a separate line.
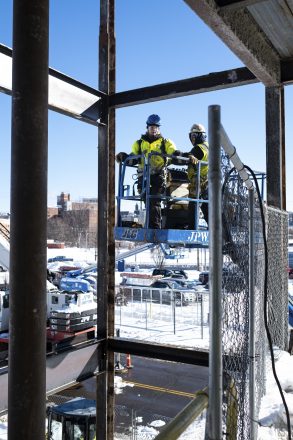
[115, 286, 209, 338]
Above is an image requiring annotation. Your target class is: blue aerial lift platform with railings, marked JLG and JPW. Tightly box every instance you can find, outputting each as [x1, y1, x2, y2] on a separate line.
[115, 153, 209, 248]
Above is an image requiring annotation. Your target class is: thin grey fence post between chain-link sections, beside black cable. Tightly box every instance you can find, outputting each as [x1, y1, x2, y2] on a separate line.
[248, 189, 256, 440]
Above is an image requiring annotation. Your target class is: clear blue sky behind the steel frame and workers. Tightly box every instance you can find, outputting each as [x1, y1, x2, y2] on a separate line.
[0, 0, 293, 211]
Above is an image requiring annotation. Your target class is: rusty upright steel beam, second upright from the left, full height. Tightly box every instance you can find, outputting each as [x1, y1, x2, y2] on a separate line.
[96, 0, 114, 440]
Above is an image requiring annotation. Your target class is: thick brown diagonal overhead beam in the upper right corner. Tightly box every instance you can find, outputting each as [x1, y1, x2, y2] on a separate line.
[184, 0, 281, 86]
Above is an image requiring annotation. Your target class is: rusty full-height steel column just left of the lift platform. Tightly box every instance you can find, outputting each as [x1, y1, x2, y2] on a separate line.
[96, 0, 115, 440]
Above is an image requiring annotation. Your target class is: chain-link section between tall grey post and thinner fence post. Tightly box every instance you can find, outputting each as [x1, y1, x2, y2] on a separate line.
[222, 172, 250, 439]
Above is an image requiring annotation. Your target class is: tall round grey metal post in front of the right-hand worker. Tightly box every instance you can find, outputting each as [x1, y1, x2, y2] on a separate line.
[208, 105, 223, 440]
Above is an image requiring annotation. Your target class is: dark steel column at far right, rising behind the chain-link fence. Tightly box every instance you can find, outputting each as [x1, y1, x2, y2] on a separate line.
[266, 86, 286, 209]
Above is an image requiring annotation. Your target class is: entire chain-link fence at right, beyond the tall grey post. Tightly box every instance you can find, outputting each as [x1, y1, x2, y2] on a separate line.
[222, 166, 288, 440]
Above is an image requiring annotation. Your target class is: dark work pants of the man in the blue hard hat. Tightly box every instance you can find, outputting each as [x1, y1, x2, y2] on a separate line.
[137, 171, 166, 229]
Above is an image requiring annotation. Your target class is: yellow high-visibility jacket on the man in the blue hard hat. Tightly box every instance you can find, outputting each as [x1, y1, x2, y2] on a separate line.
[131, 135, 176, 173]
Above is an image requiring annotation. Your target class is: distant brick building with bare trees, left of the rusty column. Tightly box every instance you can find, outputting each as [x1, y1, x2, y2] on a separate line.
[48, 192, 98, 248]
